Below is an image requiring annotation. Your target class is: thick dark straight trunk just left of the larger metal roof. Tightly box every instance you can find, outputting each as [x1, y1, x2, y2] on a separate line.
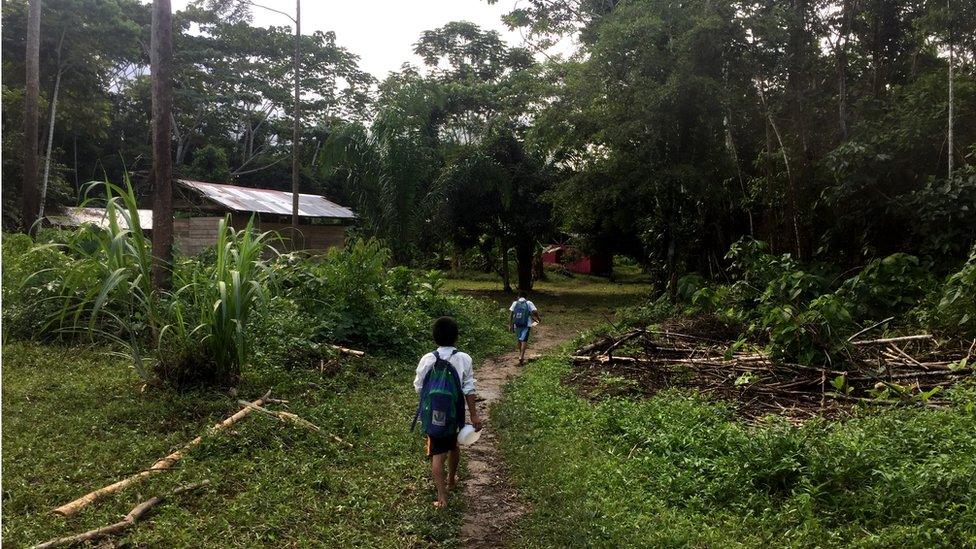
[150, 0, 173, 289]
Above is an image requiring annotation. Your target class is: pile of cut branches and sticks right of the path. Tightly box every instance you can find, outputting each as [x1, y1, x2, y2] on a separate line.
[564, 329, 976, 422]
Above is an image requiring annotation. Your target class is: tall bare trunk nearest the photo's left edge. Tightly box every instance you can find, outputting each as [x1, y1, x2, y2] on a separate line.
[22, 0, 41, 231]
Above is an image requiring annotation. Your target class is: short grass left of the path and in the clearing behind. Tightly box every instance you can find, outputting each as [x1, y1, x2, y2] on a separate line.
[3, 272, 646, 547]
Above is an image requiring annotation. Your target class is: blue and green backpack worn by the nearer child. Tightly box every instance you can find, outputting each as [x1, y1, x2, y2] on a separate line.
[410, 350, 464, 438]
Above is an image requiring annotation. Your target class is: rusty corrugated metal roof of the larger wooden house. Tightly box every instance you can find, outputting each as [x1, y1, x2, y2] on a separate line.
[178, 179, 356, 219]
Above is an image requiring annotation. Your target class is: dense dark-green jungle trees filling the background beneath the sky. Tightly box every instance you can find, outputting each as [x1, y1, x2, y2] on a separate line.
[3, 0, 976, 289]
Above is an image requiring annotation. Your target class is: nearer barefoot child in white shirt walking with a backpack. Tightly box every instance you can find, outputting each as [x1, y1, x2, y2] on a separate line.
[411, 316, 481, 509]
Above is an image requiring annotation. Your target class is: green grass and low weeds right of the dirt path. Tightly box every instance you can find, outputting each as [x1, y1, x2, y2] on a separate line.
[492, 357, 976, 547]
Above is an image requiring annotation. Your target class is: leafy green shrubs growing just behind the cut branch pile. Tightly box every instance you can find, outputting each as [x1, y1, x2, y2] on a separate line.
[648, 239, 952, 364]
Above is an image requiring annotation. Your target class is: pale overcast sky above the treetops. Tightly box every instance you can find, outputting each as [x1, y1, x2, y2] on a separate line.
[173, 0, 522, 80]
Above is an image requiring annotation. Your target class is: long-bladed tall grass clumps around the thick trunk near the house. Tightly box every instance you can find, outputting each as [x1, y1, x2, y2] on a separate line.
[29, 181, 271, 385]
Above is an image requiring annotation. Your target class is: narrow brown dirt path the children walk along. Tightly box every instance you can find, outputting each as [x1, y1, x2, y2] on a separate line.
[461, 324, 573, 548]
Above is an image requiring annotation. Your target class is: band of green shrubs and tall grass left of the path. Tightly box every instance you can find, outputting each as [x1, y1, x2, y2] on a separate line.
[3, 191, 504, 385]
